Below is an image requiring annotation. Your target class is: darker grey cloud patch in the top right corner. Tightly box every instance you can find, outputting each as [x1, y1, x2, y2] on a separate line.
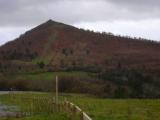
[107, 0, 160, 14]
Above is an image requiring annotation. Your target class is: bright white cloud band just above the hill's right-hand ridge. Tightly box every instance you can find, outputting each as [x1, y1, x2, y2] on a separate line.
[74, 19, 160, 41]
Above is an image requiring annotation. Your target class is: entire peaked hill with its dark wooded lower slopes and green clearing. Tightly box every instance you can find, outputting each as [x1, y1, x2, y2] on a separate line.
[0, 20, 160, 98]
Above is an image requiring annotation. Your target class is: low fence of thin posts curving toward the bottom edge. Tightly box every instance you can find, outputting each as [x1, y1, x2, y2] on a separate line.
[10, 93, 92, 120]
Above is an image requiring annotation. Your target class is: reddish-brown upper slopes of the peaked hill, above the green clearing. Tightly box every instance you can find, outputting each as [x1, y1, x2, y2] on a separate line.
[0, 20, 160, 70]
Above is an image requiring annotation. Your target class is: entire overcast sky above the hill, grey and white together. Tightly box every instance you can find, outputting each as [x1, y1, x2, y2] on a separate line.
[0, 0, 160, 44]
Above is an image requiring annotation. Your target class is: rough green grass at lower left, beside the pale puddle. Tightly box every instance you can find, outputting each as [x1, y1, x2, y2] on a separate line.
[0, 92, 71, 120]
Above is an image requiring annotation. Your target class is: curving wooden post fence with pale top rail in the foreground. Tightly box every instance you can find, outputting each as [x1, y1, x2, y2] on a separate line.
[10, 93, 92, 120]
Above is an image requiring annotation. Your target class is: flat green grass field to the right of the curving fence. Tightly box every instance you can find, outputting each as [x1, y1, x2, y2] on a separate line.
[0, 93, 160, 120]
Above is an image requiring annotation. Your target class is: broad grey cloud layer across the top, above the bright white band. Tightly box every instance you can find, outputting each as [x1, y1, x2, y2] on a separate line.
[0, 0, 160, 26]
